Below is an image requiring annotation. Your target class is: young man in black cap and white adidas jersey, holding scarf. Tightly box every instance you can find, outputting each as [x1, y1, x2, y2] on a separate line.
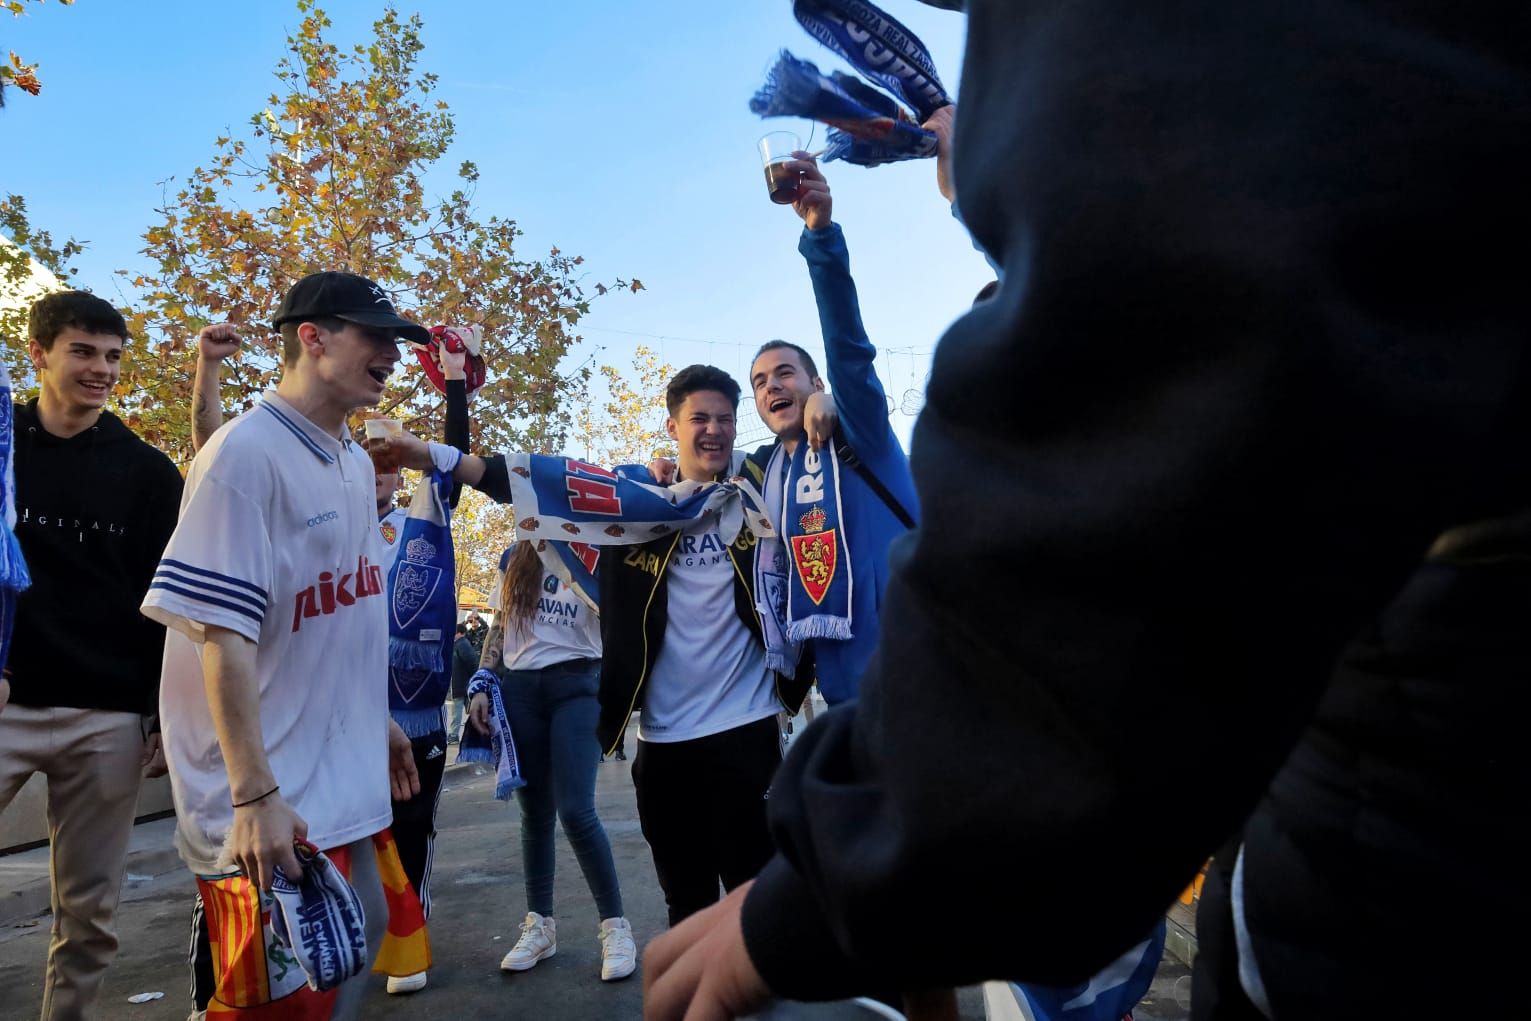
[144, 272, 427, 1018]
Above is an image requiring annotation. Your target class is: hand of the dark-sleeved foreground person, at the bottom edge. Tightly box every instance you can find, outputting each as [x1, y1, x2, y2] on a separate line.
[643, 880, 770, 1021]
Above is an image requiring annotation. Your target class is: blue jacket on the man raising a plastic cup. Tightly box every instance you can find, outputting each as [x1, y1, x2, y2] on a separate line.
[747, 223, 920, 706]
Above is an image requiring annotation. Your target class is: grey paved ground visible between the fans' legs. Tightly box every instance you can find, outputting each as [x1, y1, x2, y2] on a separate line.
[0, 722, 1190, 1021]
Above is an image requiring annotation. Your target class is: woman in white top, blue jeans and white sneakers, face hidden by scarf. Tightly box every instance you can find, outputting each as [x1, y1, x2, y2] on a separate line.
[468, 542, 638, 981]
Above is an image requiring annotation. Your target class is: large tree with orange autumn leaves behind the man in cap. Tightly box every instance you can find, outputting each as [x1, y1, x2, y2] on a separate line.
[110, 0, 630, 461]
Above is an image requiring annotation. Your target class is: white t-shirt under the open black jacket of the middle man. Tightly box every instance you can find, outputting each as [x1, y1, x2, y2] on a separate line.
[638, 528, 779, 742]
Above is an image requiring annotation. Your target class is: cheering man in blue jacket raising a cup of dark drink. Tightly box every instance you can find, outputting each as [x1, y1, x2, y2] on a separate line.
[747, 153, 919, 706]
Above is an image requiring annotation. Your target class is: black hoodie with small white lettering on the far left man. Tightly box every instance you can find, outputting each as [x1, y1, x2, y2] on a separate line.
[6, 398, 182, 715]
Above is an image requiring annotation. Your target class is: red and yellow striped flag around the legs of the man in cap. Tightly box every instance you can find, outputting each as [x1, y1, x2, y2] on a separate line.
[196, 830, 430, 1021]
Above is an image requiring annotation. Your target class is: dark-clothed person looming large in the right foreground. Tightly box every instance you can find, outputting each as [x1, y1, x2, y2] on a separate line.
[643, 0, 1531, 1021]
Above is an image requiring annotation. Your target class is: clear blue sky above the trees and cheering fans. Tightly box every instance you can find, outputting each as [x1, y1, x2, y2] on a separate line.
[0, 0, 992, 446]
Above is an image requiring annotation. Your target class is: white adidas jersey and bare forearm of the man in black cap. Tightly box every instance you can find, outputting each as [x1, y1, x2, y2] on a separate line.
[144, 392, 392, 874]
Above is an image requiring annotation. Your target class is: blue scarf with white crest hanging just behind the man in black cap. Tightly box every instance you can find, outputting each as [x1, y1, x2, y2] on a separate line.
[387, 470, 458, 738]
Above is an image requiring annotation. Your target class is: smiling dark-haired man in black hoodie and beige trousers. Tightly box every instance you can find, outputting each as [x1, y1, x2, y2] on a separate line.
[0, 291, 181, 1018]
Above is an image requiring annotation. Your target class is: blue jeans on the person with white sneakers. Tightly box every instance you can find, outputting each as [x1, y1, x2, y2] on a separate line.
[499, 660, 623, 918]
